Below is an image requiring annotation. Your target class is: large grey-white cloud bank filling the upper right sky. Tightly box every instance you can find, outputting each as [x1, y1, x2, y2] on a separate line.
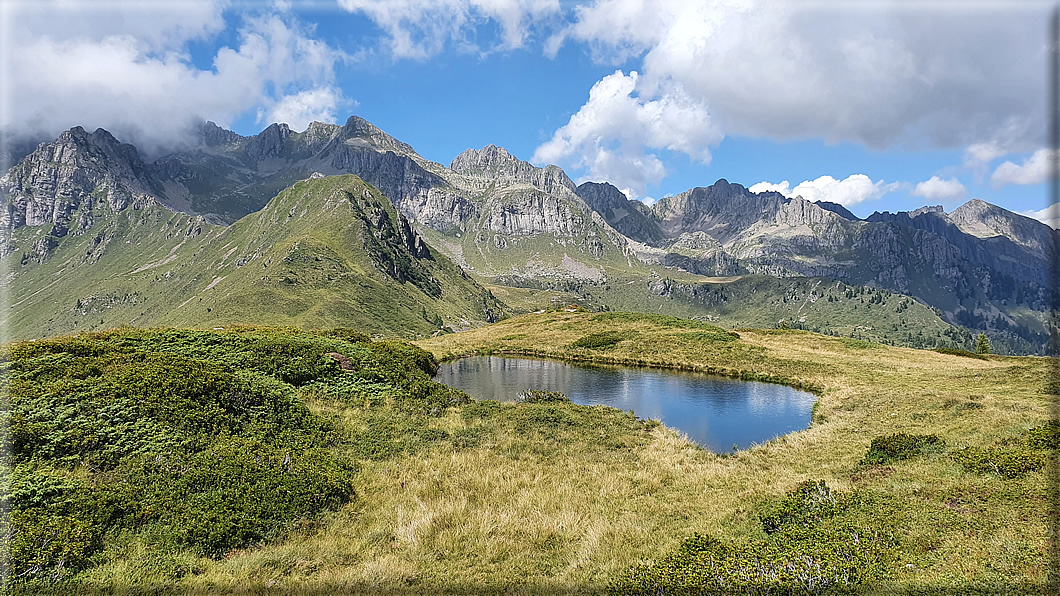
[566, 0, 1048, 147]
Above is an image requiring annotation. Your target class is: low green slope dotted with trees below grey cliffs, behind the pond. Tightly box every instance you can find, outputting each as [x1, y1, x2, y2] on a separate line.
[492, 269, 975, 350]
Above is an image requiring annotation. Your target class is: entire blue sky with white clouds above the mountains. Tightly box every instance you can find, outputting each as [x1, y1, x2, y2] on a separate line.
[0, 0, 1060, 227]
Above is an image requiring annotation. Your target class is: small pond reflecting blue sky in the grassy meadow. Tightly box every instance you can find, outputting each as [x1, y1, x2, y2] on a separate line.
[435, 356, 816, 452]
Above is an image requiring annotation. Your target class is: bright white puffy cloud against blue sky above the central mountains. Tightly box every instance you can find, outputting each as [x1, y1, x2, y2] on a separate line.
[532, 70, 722, 196]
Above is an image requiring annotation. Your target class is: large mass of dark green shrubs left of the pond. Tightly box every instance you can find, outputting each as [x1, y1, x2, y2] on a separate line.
[0, 328, 455, 588]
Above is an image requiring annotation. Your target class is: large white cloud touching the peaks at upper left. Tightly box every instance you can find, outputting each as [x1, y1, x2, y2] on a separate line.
[0, 2, 346, 152]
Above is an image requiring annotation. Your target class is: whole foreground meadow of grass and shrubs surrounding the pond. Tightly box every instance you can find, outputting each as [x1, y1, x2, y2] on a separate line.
[2, 312, 1060, 594]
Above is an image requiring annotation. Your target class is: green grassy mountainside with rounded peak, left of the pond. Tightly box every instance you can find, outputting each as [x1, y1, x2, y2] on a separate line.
[0, 175, 506, 337]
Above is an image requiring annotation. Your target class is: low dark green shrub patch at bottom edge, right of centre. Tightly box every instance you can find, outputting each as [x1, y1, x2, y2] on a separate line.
[610, 480, 896, 595]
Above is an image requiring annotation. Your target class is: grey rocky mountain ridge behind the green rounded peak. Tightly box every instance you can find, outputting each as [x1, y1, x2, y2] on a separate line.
[0, 117, 1057, 352]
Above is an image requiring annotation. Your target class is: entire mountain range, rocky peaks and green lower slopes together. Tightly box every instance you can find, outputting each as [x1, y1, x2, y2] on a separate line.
[0, 117, 1057, 353]
